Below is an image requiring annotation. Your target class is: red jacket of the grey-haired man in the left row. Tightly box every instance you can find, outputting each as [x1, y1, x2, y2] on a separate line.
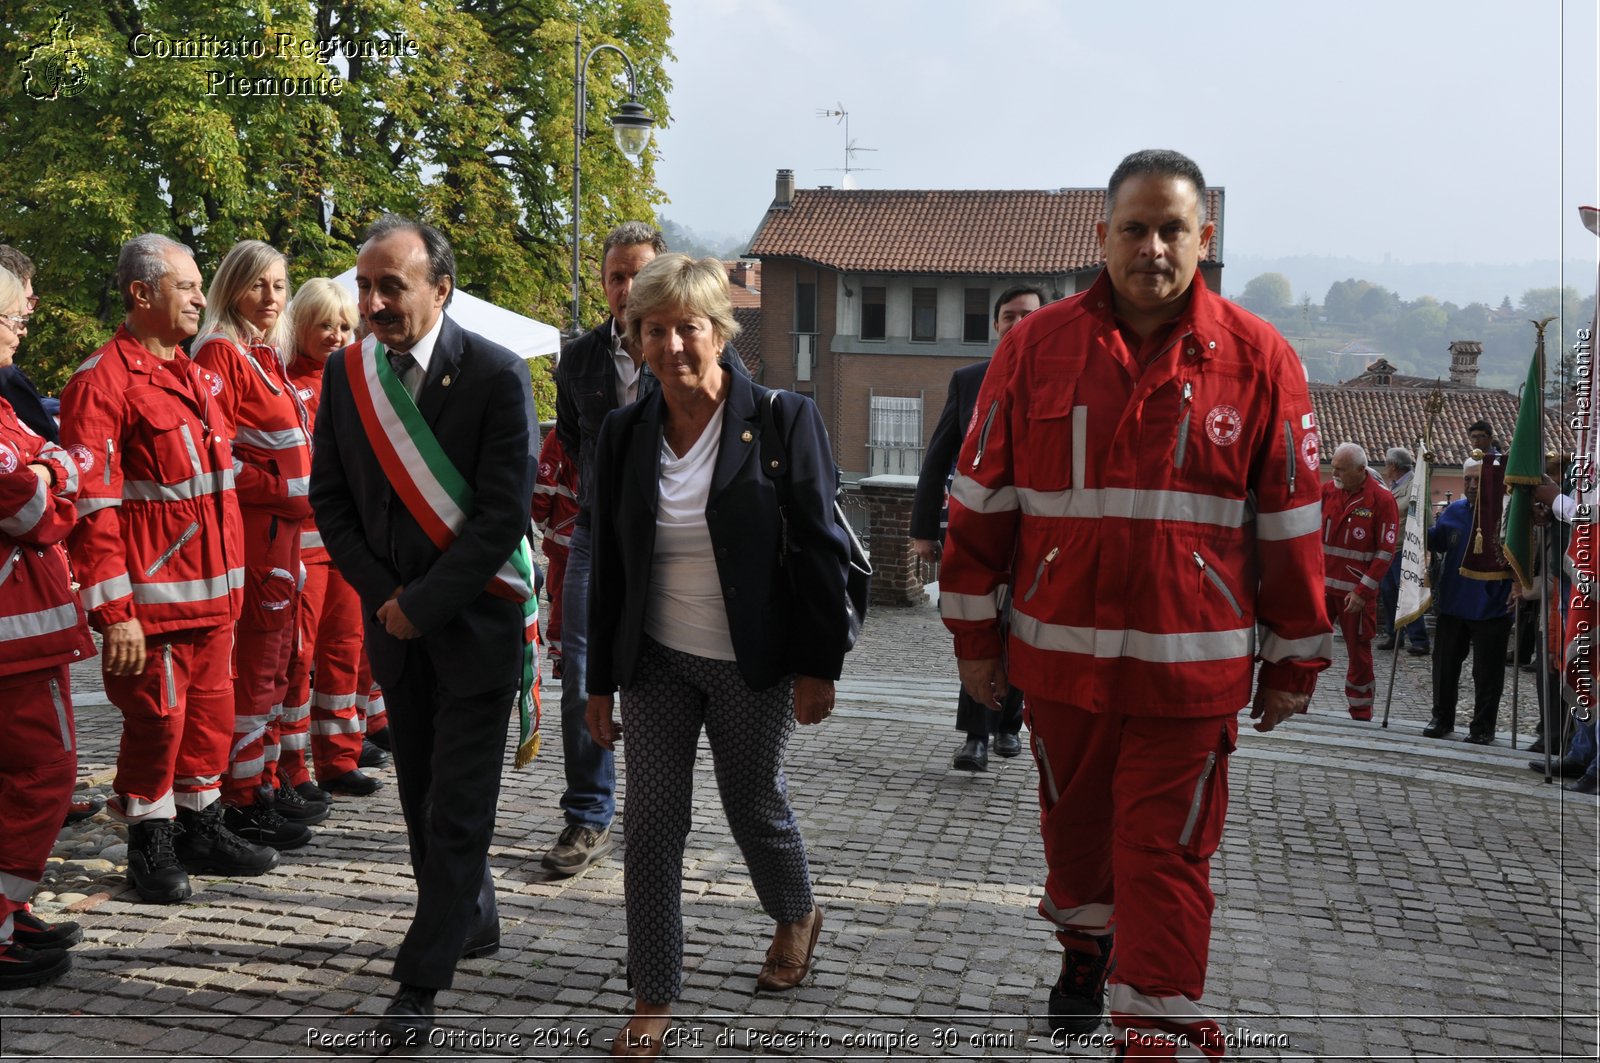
[61, 327, 245, 634]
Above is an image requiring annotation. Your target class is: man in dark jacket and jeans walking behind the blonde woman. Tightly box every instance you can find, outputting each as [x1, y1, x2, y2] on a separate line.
[542, 221, 749, 876]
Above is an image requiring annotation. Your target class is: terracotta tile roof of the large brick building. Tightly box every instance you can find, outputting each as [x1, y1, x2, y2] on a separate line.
[747, 189, 1224, 275]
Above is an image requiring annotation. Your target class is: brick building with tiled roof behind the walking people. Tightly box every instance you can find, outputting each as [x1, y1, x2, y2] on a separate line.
[741, 170, 1224, 482]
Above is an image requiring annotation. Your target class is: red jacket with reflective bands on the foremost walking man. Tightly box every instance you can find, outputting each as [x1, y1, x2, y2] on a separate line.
[939, 274, 1331, 716]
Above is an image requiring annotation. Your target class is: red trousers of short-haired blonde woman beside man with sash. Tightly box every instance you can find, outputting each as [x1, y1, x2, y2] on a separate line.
[278, 560, 370, 786]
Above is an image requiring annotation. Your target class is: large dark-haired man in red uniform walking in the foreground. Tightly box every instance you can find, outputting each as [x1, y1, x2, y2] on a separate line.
[939, 150, 1330, 1058]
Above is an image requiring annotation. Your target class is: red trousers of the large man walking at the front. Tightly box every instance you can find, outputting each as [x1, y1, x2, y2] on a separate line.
[1026, 693, 1238, 1058]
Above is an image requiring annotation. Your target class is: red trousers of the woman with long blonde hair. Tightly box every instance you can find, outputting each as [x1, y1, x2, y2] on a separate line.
[222, 560, 299, 805]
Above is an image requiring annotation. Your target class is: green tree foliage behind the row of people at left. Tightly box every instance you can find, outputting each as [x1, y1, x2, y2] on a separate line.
[0, 0, 670, 419]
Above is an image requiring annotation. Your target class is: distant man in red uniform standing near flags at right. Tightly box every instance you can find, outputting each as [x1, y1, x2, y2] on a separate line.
[1322, 443, 1400, 720]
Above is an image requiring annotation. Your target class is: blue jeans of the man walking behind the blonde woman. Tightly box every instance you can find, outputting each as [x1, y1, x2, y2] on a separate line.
[562, 527, 616, 831]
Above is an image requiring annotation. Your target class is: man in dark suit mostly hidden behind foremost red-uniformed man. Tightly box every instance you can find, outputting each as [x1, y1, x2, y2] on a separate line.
[910, 285, 1045, 772]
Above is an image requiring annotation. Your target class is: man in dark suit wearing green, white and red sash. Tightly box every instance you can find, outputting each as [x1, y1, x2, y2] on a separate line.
[310, 215, 536, 1039]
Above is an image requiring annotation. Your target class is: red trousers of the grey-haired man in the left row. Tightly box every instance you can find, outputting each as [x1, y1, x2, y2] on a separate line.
[106, 623, 234, 823]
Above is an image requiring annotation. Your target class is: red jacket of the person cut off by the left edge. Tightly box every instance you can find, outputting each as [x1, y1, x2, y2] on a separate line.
[0, 399, 94, 676]
